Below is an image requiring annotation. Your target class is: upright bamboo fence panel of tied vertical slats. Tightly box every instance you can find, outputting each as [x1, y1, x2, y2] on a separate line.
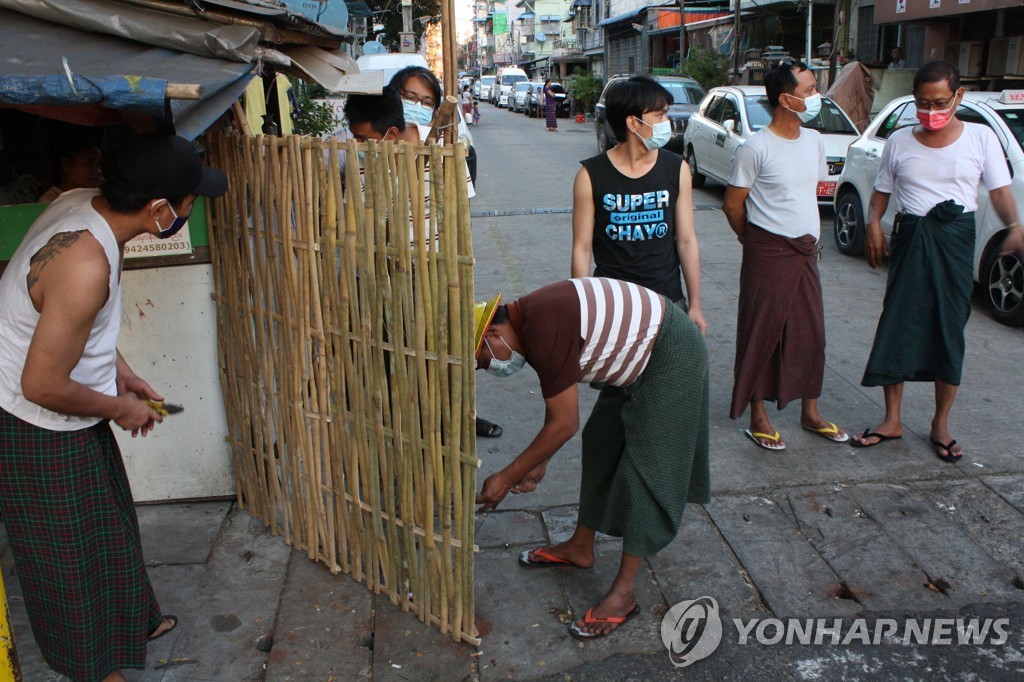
[207, 134, 479, 644]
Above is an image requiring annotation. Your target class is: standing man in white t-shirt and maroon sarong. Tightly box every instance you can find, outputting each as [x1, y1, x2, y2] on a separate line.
[722, 59, 850, 450]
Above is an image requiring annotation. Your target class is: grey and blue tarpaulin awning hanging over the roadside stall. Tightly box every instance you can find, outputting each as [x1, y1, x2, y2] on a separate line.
[0, 9, 255, 138]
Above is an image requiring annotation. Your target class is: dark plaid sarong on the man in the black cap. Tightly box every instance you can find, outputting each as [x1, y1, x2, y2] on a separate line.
[0, 410, 161, 682]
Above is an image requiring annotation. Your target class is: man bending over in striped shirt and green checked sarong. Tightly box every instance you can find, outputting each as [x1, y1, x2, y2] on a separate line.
[475, 278, 711, 639]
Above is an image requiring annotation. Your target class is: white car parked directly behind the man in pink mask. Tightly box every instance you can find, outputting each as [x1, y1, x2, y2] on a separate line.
[835, 90, 1024, 327]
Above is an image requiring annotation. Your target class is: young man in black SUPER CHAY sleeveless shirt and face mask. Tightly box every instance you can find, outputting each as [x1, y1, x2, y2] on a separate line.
[571, 76, 708, 332]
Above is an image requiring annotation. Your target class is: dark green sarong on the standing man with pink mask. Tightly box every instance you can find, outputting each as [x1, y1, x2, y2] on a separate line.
[861, 199, 975, 386]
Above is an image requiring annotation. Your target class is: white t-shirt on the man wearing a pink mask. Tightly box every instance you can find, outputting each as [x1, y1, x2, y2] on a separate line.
[874, 123, 1011, 215]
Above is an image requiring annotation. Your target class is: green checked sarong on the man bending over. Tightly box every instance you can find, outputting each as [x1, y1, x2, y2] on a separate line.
[580, 303, 711, 556]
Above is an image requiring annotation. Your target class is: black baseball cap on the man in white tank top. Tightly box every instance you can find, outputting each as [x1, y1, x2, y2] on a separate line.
[111, 133, 227, 199]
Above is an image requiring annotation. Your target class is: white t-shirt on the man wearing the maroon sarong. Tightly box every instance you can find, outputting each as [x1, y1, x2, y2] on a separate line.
[729, 127, 828, 240]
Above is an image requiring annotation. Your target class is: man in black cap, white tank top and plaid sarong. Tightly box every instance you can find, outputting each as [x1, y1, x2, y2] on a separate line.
[0, 134, 227, 680]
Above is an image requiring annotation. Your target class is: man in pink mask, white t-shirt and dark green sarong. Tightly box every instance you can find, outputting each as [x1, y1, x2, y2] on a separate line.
[853, 61, 1022, 462]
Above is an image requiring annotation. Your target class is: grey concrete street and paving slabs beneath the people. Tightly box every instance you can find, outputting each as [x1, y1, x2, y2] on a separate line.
[2, 108, 1024, 681]
